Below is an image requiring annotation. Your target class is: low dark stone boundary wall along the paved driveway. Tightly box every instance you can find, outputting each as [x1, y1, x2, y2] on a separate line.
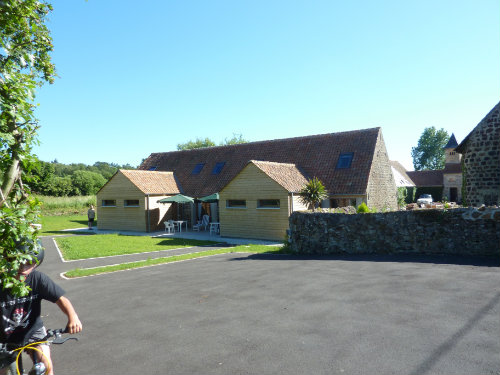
[290, 208, 500, 256]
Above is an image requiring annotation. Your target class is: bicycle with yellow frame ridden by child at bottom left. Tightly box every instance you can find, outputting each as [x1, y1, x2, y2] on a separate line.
[0, 328, 78, 375]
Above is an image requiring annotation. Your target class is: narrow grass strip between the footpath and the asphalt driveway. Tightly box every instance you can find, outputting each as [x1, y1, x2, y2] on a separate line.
[64, 245, 287, 278]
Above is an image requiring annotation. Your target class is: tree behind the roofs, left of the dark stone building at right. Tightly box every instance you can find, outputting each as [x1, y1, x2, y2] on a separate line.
[411, 126, 450, 171]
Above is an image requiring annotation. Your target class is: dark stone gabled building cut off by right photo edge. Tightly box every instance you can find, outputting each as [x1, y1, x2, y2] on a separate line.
[456, 102, 500, 206]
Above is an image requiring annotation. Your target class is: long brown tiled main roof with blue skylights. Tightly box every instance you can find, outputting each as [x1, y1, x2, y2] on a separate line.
[139, 128, 381, 198]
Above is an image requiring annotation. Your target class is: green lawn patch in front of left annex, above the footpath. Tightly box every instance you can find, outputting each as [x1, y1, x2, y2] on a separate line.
[55, 234, 216, 260]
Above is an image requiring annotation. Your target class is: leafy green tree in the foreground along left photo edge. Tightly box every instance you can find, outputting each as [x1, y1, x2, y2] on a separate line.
[0, 0, 55, 295]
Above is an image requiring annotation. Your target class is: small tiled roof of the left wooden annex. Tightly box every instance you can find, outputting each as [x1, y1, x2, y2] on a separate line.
[119, 169, 180, 194]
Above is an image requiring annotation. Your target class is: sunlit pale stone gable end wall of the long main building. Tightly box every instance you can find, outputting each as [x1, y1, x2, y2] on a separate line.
[366, 132, 398, 210]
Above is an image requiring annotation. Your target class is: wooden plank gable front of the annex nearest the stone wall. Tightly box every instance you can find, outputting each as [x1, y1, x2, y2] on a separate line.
[219, 164, 289, 241]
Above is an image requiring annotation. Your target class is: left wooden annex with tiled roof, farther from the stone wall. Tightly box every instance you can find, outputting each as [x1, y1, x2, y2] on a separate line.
[97, 169, 180, 232]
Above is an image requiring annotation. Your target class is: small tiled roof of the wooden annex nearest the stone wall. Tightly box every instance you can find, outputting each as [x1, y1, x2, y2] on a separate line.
[250, 160, 307, 193]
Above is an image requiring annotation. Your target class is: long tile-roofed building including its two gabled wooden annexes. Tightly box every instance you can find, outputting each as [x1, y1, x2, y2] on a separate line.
[98, 128, 397, 240]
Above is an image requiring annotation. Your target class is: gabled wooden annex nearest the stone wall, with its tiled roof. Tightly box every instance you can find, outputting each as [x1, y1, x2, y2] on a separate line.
[219, 160, 307, 241]
